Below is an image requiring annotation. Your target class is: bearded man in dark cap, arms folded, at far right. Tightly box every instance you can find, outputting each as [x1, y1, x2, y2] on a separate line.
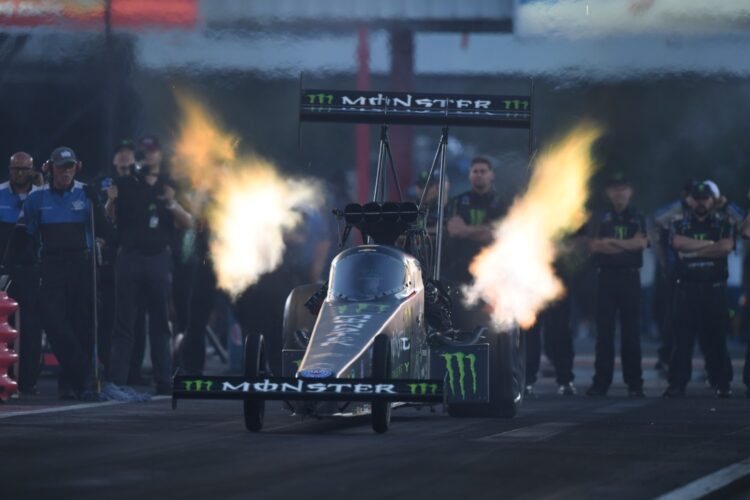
[664, 183, 734, 398]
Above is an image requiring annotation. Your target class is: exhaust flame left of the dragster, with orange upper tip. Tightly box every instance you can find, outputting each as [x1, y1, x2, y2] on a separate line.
[175, 94, 321, 298]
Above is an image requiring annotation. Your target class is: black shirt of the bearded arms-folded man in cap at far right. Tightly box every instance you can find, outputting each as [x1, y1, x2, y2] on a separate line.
[672, 213, 734, 283]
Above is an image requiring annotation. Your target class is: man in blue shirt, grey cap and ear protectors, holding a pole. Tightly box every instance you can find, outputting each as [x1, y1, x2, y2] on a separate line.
[23, 147, 106, 398]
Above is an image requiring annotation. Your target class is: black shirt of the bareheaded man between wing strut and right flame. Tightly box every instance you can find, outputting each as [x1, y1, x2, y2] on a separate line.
[445, 190, 508, 281]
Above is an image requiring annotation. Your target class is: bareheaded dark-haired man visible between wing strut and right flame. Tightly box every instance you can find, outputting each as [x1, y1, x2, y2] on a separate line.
[444, 156, 508, 283]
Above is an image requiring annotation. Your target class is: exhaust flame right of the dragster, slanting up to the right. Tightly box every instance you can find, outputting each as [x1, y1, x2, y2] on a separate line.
[464, 125, 601, 329]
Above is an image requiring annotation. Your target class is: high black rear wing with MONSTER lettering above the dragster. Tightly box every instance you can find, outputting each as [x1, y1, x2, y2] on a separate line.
[299, 89, 532, 129]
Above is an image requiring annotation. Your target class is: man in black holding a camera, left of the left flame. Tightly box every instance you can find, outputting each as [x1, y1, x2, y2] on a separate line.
[106, 151, 193, 394]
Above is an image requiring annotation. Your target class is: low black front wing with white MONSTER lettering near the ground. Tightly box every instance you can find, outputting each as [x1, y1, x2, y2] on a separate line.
[172, 376, 444, 403]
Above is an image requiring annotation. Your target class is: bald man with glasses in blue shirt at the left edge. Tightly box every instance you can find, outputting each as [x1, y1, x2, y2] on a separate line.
[0, 151, 42, 395]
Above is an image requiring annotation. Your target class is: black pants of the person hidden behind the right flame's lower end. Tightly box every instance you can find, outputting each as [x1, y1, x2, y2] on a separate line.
[525, 295, 575, 385]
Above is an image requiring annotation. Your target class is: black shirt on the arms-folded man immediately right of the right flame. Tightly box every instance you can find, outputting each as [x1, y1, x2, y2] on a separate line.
[592, 207, 646, 269]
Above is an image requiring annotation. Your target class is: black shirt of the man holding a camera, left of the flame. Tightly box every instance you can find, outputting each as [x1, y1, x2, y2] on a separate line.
[115, 175, 174, 255]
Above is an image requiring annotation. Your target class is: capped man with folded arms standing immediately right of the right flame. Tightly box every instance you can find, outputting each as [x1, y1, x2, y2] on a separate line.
[586, 173, 648, 397]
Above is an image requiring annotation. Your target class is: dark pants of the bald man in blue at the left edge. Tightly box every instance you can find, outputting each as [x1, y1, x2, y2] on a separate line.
[8, 266, 42, 390]
